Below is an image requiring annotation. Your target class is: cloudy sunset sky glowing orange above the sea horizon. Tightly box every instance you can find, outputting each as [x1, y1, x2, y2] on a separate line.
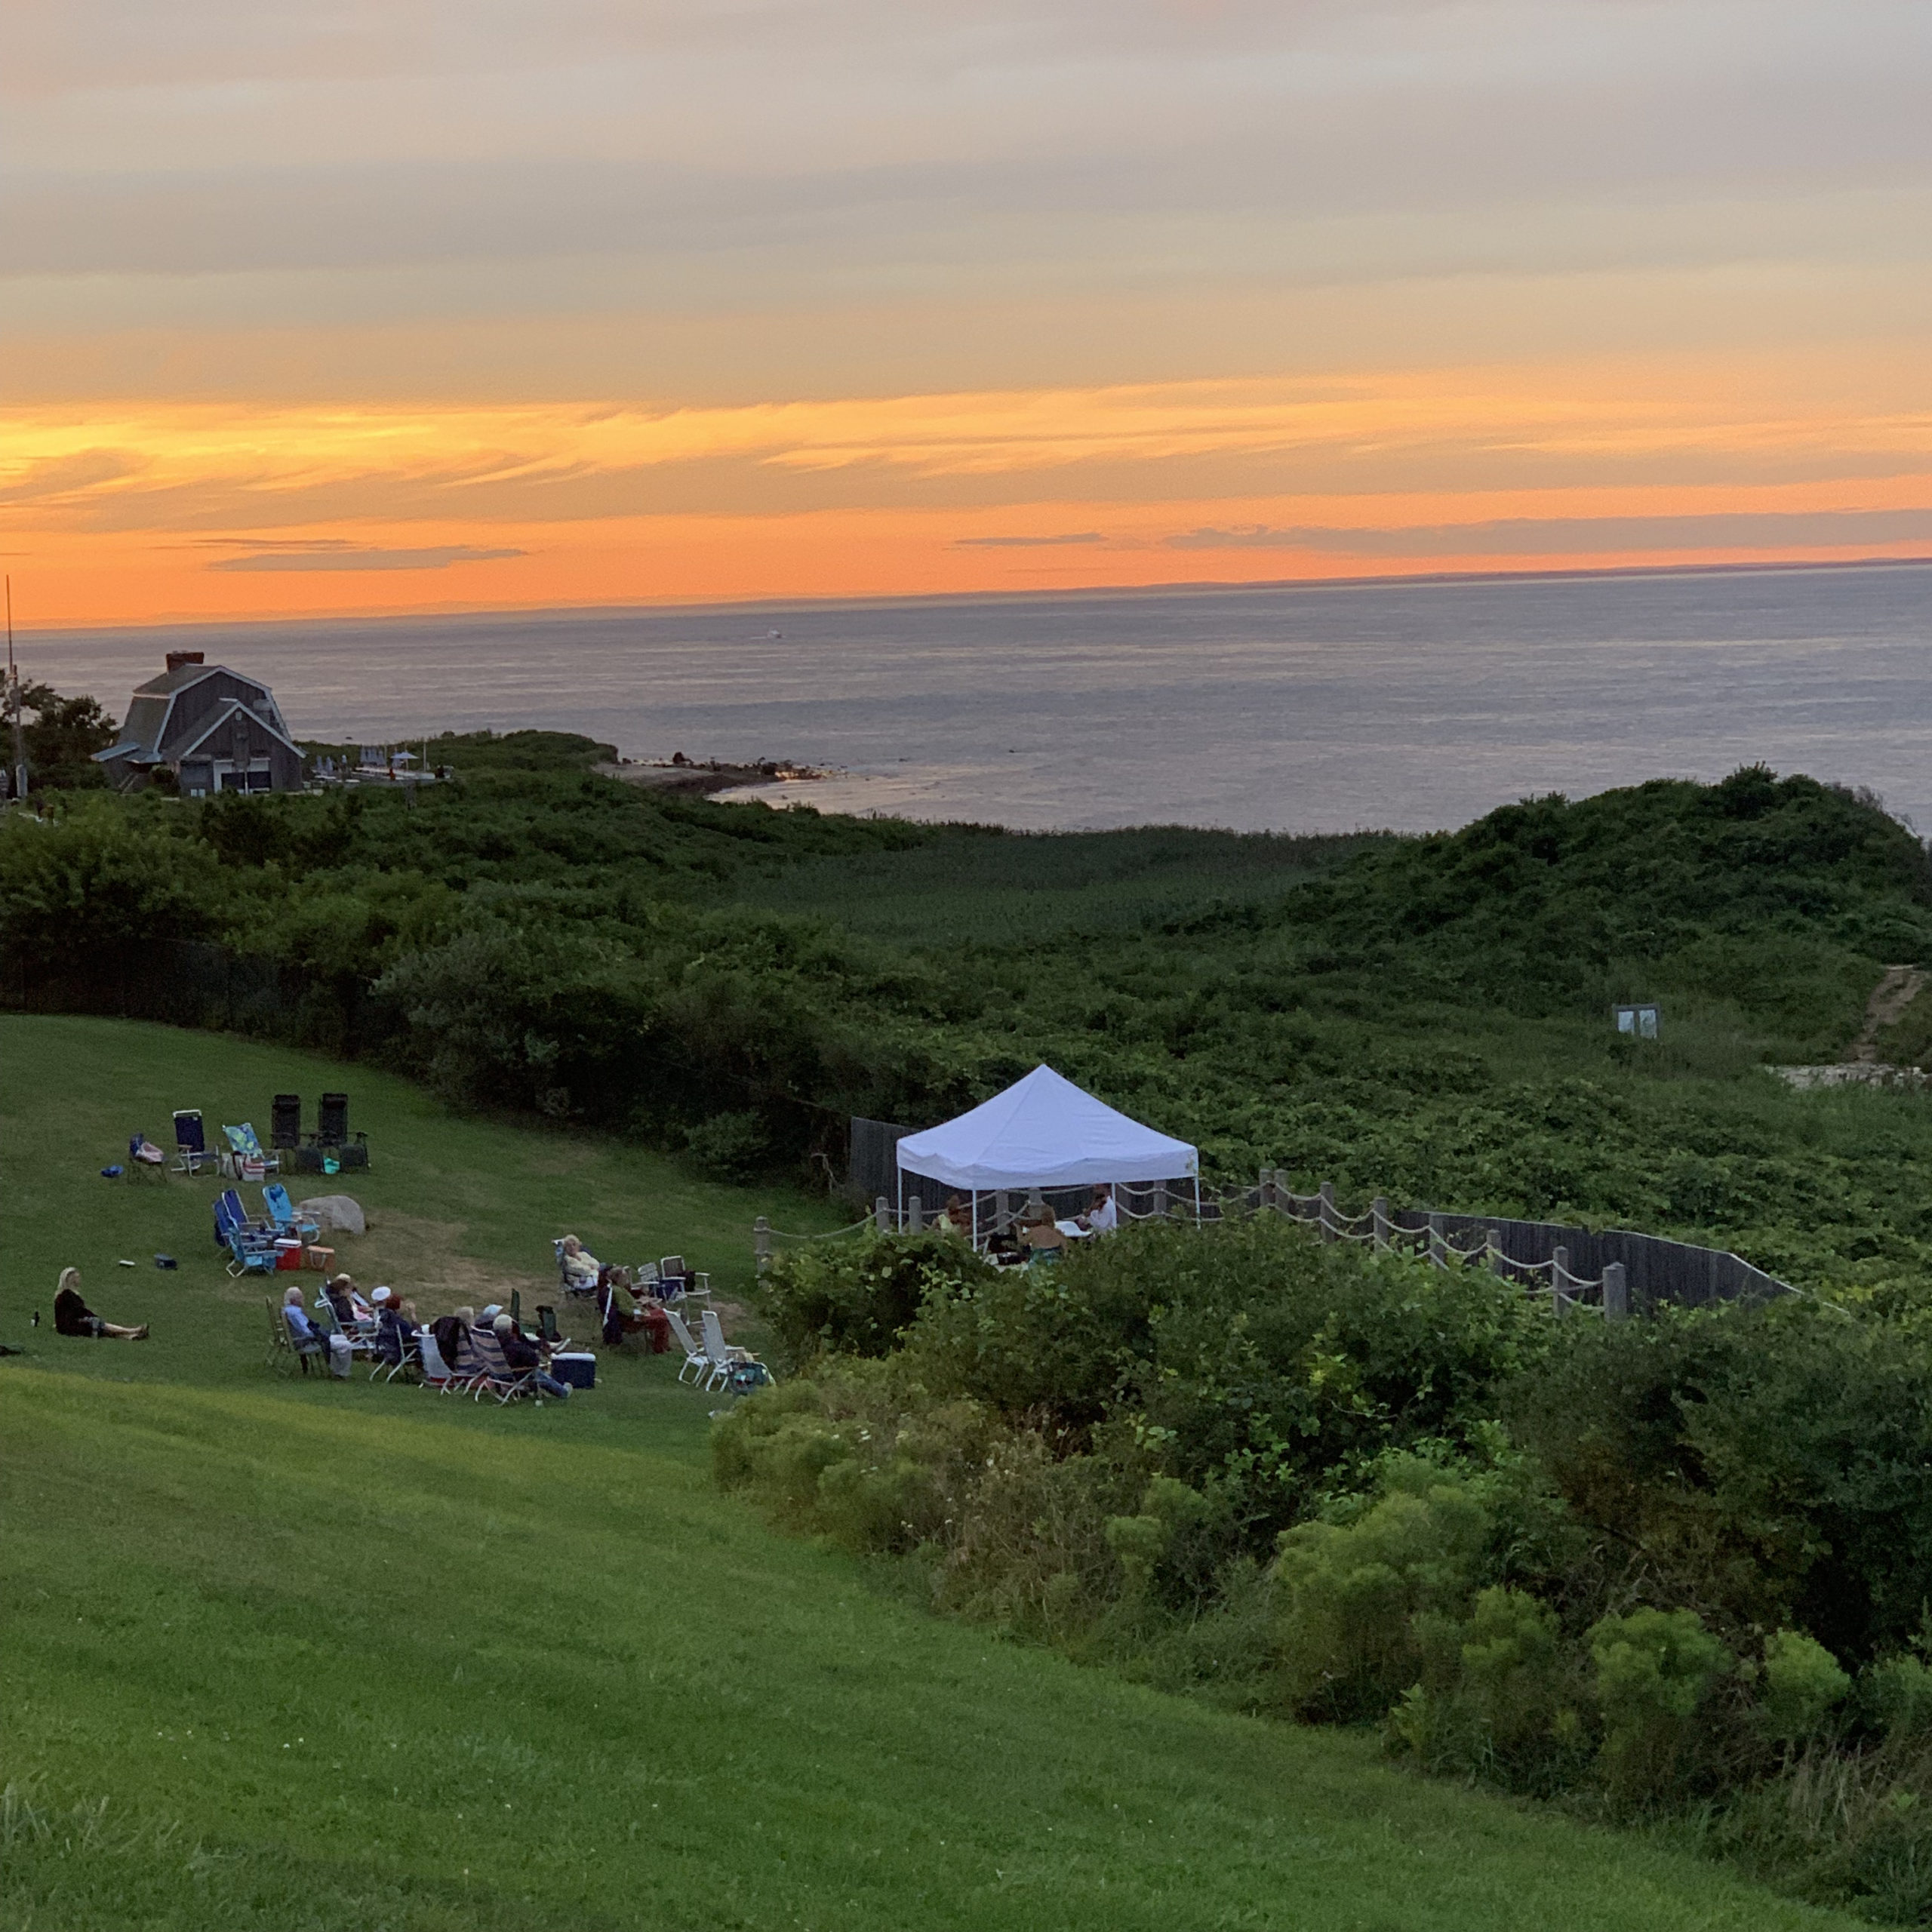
[0, 0, 1932, 628]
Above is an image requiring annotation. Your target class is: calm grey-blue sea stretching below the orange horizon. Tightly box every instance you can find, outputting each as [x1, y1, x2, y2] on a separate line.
[30, 565, 1932, 831]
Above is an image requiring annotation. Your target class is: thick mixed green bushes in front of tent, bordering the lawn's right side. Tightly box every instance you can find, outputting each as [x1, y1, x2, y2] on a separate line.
[715, 1219, 1932, 1922]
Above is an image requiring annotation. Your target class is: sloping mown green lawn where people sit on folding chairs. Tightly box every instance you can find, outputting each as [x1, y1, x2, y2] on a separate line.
[0, 1017, 1849, 1932]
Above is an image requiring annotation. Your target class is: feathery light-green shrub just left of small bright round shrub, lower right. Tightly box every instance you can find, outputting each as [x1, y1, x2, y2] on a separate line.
[1590, 1609, 1737, 1804]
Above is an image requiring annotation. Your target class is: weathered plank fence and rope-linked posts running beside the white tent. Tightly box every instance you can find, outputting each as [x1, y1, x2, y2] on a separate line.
[752, 1159, 1795, 1321]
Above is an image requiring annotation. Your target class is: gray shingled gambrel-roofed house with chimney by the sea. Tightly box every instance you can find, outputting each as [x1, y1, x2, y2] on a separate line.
[94, 651, 301, 798]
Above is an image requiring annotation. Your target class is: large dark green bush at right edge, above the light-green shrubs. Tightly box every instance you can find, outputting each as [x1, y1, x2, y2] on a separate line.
[1509, 1297, 1932, 1662]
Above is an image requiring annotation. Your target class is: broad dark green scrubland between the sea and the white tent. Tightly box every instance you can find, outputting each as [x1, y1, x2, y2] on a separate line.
[11, 757, 1932, 1312]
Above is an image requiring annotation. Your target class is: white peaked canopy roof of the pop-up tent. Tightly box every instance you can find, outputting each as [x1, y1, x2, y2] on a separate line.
[898, 1066, 1200, 1190]
